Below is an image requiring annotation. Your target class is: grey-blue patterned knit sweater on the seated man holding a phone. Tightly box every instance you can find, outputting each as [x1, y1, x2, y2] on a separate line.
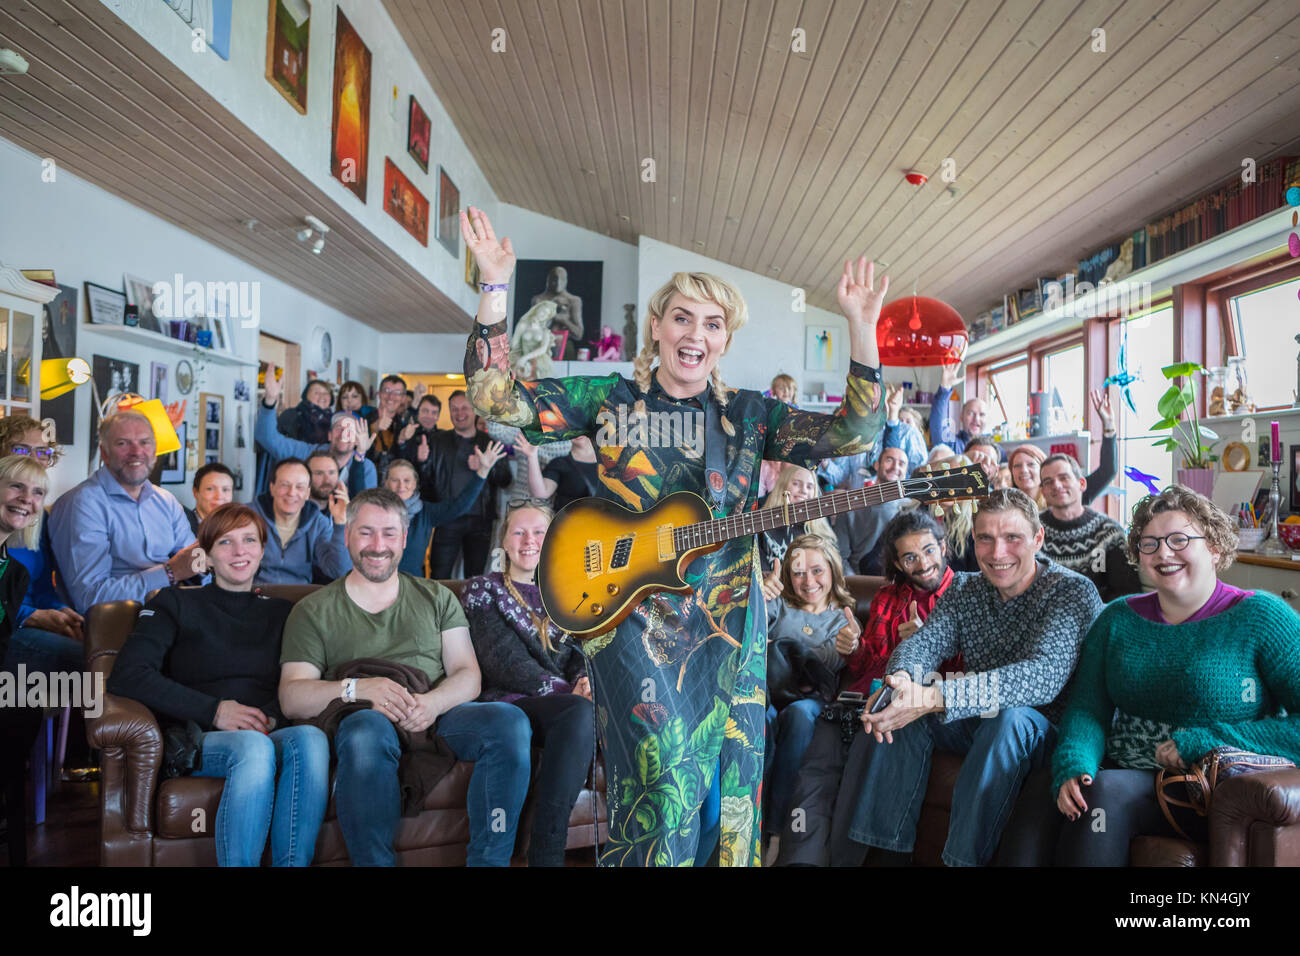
[885, 554, 1101, 723]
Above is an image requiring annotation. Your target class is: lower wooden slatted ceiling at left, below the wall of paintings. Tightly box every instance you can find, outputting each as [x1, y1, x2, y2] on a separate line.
[0, 0, 469, 332]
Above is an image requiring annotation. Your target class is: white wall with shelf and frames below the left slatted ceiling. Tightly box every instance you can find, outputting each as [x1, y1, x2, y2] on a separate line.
[0, 139, 380, 503]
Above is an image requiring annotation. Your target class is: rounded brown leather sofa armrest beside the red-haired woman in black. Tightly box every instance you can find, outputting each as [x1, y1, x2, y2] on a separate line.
[86, 693, 163, 832]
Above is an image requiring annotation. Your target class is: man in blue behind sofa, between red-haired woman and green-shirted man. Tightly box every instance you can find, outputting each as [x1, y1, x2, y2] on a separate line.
[255, 458, 352, 584]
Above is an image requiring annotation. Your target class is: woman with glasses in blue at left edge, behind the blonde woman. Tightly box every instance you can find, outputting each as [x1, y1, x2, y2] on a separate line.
[0, 415, 85, 674]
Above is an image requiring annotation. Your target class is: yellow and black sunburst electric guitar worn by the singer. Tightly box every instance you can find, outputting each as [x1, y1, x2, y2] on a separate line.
[537, 466, 988, 637]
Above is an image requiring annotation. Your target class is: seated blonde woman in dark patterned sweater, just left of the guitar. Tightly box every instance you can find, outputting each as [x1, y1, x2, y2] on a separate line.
[462, 499, 595, 866]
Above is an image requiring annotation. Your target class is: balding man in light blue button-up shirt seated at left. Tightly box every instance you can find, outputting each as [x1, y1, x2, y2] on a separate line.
[49, 411, 200, 614]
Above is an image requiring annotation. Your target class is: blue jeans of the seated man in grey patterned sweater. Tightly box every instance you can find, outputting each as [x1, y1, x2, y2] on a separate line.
[849, 708, 1056, 866]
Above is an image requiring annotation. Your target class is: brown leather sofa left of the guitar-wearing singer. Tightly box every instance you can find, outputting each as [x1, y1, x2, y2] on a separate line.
[86, 581, 607, 866]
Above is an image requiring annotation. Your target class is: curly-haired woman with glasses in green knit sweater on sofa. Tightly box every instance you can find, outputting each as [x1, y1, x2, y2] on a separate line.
[1052, 485, 1300, 866]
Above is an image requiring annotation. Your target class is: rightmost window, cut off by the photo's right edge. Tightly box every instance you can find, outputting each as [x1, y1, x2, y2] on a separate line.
[1229, 278, 1300, 408]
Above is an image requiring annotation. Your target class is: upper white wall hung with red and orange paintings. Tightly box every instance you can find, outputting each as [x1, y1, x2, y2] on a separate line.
[100, 0, 497, 313]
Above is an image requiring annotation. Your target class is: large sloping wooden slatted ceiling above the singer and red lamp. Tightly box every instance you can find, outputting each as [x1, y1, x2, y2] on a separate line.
[384, 0, 1300, 317]
